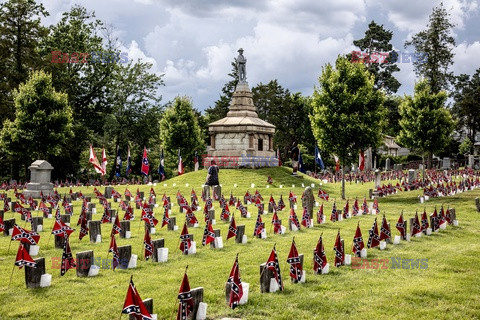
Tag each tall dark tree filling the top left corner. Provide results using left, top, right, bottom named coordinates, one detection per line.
left=0, top=0, right=49, bottom=128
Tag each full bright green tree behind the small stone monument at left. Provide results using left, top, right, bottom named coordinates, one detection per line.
left=0, top=71, right=73, bottom=178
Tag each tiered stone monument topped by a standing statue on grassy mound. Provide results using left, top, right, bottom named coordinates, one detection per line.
left=204, top=48, right=278, bottom=168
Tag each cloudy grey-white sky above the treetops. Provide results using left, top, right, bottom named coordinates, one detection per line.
left=37, top=0, right=480, bottom=110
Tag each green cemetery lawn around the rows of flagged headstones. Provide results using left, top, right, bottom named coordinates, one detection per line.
left=0, top=168, right=480, bottom=319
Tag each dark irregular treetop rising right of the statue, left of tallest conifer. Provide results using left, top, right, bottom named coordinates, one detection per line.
left=353, top=20, right=400, bottom=94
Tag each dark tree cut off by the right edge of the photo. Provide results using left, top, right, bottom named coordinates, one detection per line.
left=452, top=68, right=480, bottom=153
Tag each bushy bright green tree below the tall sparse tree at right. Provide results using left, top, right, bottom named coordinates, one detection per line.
left=398, top=80, right=454, bottom=167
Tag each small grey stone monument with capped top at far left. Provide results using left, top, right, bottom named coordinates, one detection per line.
left=23, top=160, right=53, bottom=198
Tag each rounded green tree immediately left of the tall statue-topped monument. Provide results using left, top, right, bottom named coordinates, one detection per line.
left=160, top=97, right=205, bottom=175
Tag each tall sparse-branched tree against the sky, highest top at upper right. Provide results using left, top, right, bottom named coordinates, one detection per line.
left=405, top=3, right=455, bottom=93
